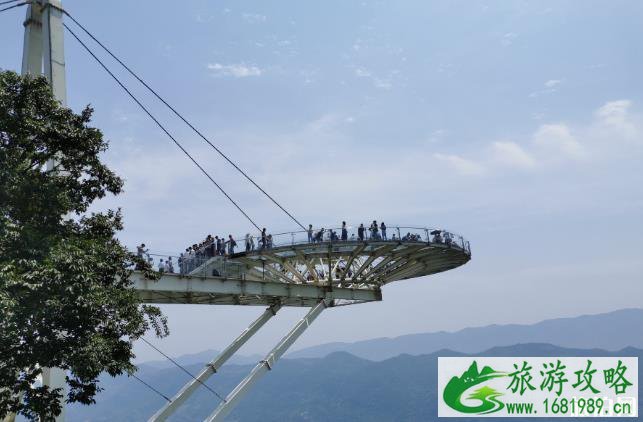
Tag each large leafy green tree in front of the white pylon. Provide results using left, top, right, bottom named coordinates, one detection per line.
left=0, top=72, right=168, bottom=420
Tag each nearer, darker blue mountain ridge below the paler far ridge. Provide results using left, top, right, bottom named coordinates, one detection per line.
left=67, top=343, right=643, bottom=422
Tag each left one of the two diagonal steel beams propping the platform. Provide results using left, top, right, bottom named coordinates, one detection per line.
left=149, top=305, right=281, bottom=422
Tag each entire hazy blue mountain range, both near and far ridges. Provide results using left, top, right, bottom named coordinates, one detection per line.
left=61, top=309, right=643, bottom=422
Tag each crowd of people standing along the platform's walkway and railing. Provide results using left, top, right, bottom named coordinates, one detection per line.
left=136, top=220, right=460, bottom=274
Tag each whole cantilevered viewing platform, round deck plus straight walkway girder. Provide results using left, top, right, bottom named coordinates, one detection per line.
left=134, top=226, right=471, bottom=306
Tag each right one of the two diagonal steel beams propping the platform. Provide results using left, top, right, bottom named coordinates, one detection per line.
left=206, top=300, right=330, bottom=422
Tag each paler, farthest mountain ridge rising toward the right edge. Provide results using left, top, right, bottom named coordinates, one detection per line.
left=286, top=309, right=643, bottom=361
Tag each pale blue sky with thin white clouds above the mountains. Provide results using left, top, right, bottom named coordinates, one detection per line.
left=0, top=0, right=643, bottom=361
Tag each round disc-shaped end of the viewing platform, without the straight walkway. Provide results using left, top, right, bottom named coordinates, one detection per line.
left=228, top=227, right=471, bottom=288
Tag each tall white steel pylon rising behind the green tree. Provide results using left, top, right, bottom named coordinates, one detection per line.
left=22, top=0, right=67, bottom=422
